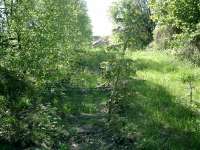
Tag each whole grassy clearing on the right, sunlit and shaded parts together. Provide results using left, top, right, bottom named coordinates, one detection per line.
left=127, top=51, right=200, bottom=149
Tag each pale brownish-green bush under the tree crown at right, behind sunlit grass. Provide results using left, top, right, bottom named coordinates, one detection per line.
left=149, top=23, right=200, bottom=65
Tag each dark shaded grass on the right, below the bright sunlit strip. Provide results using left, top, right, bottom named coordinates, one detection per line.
left=125, top=80, right=200, bottom=150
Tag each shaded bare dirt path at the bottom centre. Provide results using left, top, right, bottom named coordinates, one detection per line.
left=68, top=113, right=113, bottom=150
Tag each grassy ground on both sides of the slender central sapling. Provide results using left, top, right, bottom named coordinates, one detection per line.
left=59, top=49, right=200, bottom=150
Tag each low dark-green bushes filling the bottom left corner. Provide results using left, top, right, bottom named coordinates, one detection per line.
left=0, top=98, right=68, bottom=149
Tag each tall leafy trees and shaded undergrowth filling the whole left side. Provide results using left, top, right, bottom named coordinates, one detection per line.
left=0, top=0, right=92, bottom=149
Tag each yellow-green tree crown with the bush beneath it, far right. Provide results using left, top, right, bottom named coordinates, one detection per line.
left=150, top=0, right=200, bottom=64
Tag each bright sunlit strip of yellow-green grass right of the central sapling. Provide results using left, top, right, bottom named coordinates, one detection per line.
left=127, top=51, right=200, bottom=101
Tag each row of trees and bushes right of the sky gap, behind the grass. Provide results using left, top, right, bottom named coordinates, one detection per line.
left=111, top=0, right=200, bottom=64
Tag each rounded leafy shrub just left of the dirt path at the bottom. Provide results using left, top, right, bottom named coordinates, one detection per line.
left=20, top=104, right=68, bottom=149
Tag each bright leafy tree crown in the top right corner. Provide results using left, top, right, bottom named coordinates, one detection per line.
left=150, top=0, right=200, bottom=31
